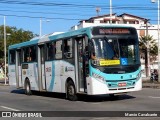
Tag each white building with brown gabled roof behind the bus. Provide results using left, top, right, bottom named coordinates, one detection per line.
left=71, top=13, right=158, bottom=77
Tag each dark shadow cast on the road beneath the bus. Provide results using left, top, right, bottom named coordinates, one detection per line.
left=11, top=89, right=135, bottom=102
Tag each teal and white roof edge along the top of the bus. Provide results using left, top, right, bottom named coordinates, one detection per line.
left=9, top=25, right=134, bottom=49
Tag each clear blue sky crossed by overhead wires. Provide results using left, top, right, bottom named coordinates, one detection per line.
left=0, top=0, right=158, bottom=35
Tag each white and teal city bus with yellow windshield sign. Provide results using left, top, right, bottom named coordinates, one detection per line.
left=8, top=25, right=142, bottom=101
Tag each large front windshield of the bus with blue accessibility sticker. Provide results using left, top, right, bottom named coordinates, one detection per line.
left=92, top=37, right=140, bottom=65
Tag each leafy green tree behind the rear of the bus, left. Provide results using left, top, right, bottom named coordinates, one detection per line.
left=0, top=25, right=37, bottom=62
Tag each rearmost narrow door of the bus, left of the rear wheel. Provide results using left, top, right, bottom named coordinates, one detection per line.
left=16, top=49, right=23, bottom=88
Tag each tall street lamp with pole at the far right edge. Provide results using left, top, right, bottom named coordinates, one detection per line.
left=151, top=0, right=160, bottom=81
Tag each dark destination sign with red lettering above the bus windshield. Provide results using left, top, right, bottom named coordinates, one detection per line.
left=92, top=27, right=132, bottom=35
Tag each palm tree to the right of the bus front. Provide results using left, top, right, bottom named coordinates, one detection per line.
left=139, top=35, right=158, bottom=77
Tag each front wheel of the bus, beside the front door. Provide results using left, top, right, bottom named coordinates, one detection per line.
left=66, top=80, right=77, bottom=101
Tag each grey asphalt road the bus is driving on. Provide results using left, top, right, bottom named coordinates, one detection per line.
left=0, top=86, right=160, bottom=120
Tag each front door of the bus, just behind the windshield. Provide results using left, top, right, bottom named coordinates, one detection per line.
left=75, top=37, right=88, bottom=92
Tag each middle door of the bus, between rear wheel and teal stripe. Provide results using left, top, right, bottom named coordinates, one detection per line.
left=38, top=45, right=46, bottom=90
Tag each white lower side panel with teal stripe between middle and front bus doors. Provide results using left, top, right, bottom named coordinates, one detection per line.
left=45, top=60, right=75, bottom=93
